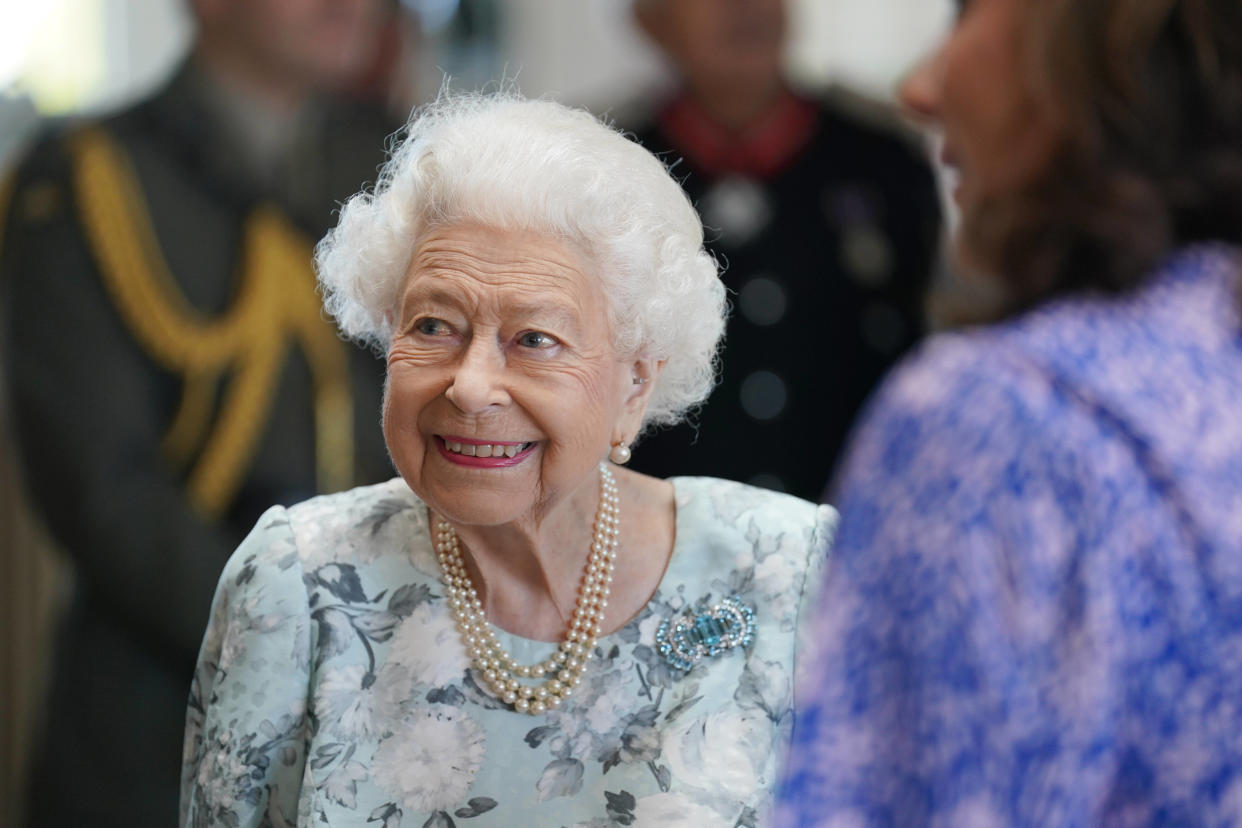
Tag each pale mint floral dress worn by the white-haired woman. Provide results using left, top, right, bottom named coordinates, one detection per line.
left=181, top=478, right=836, bottom=828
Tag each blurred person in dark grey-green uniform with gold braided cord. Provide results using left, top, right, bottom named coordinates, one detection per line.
left=0, top=0, right=395, bottom=826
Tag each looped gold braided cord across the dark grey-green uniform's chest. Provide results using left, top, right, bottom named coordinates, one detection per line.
left=72, top=129, right=353, bottom=516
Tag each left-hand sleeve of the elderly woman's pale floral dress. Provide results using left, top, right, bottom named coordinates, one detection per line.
left=181, top=506, right=312, bottom=828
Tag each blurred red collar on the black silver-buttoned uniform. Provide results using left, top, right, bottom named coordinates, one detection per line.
left=660, top=92, right=816, bottom=179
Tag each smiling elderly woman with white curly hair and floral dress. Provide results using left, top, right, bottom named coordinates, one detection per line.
left=183, top=96, right=833, bottom=828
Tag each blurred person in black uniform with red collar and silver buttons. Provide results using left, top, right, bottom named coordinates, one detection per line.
left=625, top=0, right=940, bottom=500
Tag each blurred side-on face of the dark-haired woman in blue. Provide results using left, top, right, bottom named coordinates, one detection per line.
left=900, top=0, right=1061, bottom=221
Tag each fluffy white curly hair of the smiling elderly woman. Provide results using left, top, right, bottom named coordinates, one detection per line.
left=315, top=91, right=725, bottom=428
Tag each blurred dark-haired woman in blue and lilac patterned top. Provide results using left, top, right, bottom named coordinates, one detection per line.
left=777, top=0, right=1242, bottom=826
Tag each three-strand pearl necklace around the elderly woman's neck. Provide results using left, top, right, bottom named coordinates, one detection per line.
left=436, top=464, right=621, bottom=715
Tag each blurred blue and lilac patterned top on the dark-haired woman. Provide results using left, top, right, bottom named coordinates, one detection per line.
left=776, top=247, right=1242, bottom=827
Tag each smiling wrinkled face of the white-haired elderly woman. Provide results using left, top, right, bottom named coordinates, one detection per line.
left=384, top=225, right=653, bottom=525
